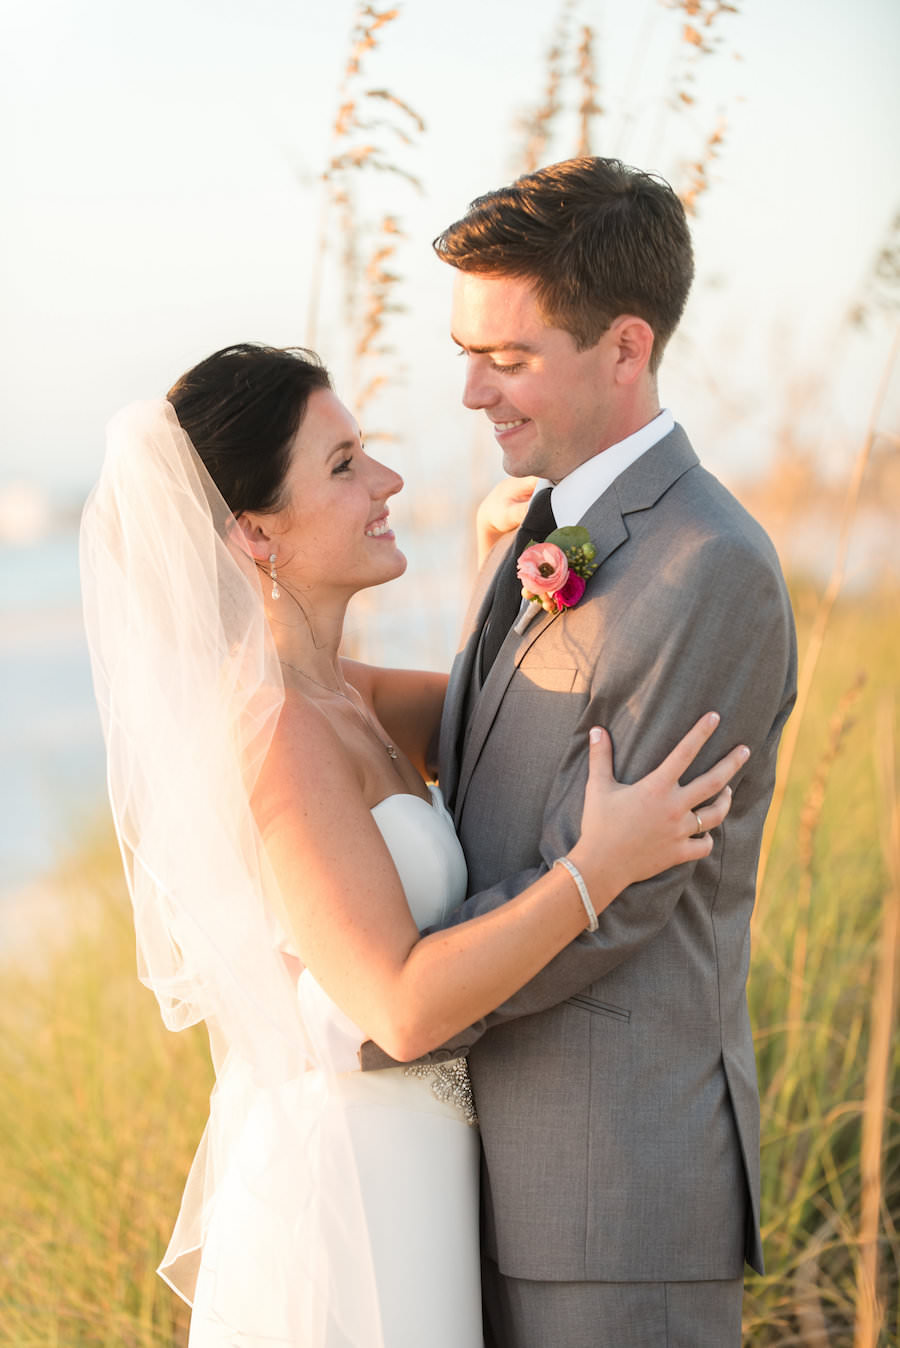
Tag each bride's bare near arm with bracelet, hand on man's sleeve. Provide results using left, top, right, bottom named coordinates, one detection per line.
left=253, top=697, right=742, bottom=1061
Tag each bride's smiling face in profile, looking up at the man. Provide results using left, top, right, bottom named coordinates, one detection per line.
left=261, top=388, right=407, bottom=592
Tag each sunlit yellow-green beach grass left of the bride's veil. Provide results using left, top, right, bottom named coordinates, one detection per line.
left=0, top=826, right=213, bottom=1348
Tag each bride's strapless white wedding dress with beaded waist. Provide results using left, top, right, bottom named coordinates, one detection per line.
left=181, top=787, right=482, bottom=1348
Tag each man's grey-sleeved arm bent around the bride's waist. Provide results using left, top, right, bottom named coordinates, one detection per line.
left=361, top=531, right=795, bottom=1068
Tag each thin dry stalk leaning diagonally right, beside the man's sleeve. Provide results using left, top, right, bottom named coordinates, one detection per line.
left=752, top=328, right=900, bottom=936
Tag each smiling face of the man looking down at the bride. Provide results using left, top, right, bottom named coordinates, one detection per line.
left=451, top=271, right=618, bottom=483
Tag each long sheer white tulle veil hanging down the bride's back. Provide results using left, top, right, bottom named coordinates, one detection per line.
left=81, top=399, right=380, bottom=1348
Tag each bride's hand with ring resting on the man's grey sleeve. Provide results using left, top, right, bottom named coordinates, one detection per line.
left=570, top=712, right=750, bottom=911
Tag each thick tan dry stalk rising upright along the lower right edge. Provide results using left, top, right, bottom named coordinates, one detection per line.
left=853, top=694, right=900, bottom=1348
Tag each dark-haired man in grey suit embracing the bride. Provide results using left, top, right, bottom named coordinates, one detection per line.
left=372, top=159, right=795, bottom=1348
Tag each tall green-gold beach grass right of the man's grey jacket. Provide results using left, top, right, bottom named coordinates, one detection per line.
left=745, top=586, right=900, bottom=1348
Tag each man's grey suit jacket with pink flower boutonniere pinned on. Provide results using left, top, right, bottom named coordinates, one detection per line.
left=364, top=427, right=796, bottom=1282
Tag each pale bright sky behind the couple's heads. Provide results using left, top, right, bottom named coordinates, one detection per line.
left=0, top=0, right=900, bottom=493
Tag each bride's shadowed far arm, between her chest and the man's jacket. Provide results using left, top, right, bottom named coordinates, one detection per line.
left=341, top=659, right=447, bottom=780
